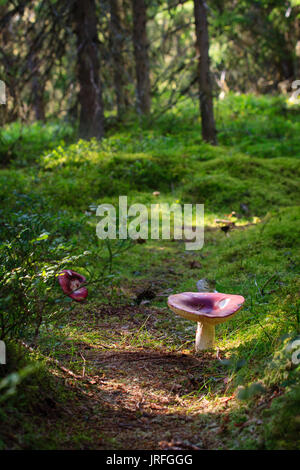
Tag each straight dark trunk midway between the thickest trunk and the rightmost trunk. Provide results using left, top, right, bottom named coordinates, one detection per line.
left=132, top=0, right=151, bottom=114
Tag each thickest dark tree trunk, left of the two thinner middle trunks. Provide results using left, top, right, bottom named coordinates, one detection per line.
left=73, top=0, right=104, bottom=139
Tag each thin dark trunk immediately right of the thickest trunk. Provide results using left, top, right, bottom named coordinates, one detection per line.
left=109, top=0, right=127, bottom=119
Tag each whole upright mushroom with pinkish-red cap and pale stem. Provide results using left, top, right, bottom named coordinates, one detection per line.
left=168, top=292, right=245, bottom=352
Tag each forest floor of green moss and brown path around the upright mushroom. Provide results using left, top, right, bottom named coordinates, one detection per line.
left=0, top=96, right=300, bottom=450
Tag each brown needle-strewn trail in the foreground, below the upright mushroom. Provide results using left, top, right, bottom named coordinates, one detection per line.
left=44, top=306, right=240, bottom=450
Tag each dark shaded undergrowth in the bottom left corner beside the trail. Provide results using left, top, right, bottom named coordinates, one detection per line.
left=0, top=342, right=97, bottom=450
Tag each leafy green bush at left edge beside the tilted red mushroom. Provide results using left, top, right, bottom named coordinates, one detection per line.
left=0, top=195, right=131, bottom=340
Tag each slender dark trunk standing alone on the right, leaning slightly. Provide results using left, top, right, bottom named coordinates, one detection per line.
left=194, top=0, right=217, bottom=145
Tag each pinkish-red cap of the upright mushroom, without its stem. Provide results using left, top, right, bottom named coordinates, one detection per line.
left=168, top=292, right=245, bottom=325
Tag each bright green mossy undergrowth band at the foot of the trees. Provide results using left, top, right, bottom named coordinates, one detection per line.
left=0, top=95, right=300, bottom=215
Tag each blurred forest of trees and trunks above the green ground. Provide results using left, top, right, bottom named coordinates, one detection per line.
left=0, top=0, right=300, bottom=138
